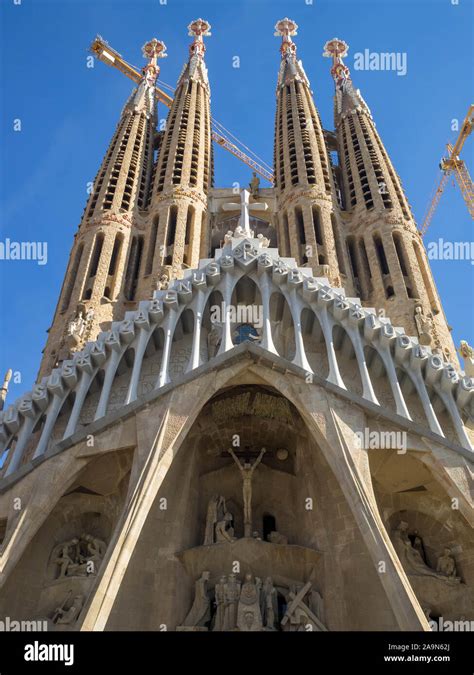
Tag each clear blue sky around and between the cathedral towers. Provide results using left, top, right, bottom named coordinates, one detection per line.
left=0, top=0, right=474, bottom=401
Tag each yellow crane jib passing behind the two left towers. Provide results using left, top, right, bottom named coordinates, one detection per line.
left=90, top=35, right=274, bottom=185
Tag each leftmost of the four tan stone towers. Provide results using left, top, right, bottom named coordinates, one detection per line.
left=39, top=38, right=166, bottom=378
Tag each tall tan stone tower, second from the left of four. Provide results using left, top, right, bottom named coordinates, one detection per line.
left=142, top=19, right=213, bottom=290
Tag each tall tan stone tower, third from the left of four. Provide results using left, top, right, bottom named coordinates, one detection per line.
left=274, top=19, right=346, bottom=285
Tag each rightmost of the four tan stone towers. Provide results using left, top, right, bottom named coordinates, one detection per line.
left=324, top=38, right=456, bottom=361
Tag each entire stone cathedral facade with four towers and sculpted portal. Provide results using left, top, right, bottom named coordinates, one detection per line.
left=0, top=19, right=474, bottom=631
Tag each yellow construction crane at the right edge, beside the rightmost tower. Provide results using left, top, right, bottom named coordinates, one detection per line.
left=420, top=105, right=474, bottom=236
